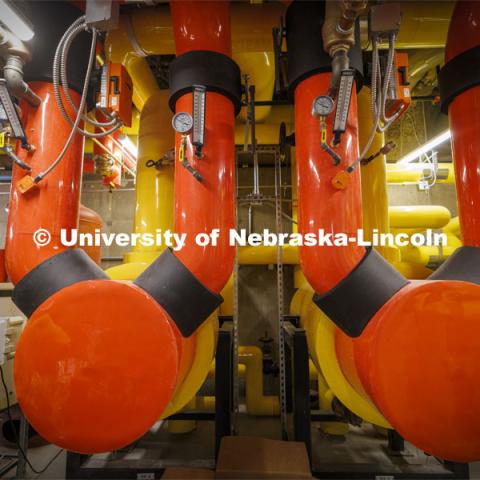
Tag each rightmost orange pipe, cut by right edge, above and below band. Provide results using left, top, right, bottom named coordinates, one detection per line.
left=445, top=1, right=480, bottom=247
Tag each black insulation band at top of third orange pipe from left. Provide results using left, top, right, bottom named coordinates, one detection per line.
left=286, top=0, right=363, bottom=93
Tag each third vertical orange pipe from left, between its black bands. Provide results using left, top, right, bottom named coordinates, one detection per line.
left=295, top=73, right=365, bottom=294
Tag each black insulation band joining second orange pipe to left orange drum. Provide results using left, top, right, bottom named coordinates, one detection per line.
left=134, top=249, right=223, bottom=337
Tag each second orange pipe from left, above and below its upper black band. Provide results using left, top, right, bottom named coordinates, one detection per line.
left=171, top=1, right=235, bottom=293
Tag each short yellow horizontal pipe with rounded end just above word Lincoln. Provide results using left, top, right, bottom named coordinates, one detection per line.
left=388, top=205, right=451, bottom=229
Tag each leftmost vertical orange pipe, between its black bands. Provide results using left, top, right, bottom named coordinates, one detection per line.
left=5, top=82, right=83, bottom=284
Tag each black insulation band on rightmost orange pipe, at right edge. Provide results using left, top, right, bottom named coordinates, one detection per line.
left=438, top=45, right=480, bottom=114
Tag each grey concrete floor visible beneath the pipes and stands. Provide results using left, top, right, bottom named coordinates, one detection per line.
left=0, top=415, right=480, bottom=480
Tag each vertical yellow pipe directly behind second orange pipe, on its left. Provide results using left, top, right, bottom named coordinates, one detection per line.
left=124, top=90, right=175, bottom=263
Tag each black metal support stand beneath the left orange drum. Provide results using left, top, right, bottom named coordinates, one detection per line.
left=65, top=317, right=233, bottom=480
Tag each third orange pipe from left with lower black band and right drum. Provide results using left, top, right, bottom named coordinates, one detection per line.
left=287, top=2, right=480, bottom=462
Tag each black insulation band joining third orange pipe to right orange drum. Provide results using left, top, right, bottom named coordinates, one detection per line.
left=313, top=247, right=409, bottom=337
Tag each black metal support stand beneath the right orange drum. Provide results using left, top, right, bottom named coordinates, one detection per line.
left=284, top=317, right=470, bottom=480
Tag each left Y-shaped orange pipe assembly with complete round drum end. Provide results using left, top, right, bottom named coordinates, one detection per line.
left=6, top=2, right=240, bottom=453
